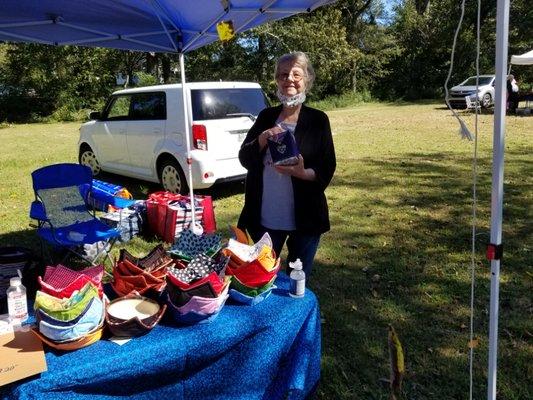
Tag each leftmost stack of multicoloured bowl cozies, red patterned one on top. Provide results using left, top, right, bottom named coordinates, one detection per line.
left=33, top=265, right=105, bottom=350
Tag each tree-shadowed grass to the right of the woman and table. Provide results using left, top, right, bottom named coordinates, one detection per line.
left=309, top=149, right=533, bottom=399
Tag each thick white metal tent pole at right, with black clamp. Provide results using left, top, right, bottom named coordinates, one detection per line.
left=487, top=0, right=509, bottom=400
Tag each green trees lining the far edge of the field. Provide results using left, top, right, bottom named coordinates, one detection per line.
left=0, top=0, right=533, bottom=121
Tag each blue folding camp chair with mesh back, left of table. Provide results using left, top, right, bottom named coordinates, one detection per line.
left=30, top=164, right=120, bottom=265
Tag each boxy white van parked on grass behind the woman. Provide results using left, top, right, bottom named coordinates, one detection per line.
left=78, top=82, right=268, bottom=193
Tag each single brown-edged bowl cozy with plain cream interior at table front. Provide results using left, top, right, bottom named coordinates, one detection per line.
left=106, top=293, right=167, bottom=337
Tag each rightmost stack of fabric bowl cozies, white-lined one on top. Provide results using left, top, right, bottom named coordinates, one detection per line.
left=222, top=233, right=280, bottom=305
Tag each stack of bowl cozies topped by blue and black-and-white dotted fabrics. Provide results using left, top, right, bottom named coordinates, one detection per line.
left=165, top=230, right=229, bottom=324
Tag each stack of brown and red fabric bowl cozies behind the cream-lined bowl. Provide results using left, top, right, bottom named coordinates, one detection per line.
left=111, top=245, right=172, bottom=299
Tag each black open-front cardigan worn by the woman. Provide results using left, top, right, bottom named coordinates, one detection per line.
left=238, top=106, right=336, bottom=234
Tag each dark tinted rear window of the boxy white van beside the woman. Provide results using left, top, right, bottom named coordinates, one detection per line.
left=191, top=88, right=268, bottom=121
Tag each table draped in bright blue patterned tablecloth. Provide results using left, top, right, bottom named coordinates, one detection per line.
left=0, top=273, right=321, bottom=400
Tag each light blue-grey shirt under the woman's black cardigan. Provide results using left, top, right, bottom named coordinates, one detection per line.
left=261, top=123, right=296, bottom=231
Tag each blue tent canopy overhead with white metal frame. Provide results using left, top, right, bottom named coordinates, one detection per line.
left=0, top=0, right=335, bottom=53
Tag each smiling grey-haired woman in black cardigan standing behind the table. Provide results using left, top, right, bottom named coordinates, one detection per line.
left=238, top=52, right=336, bottom=276
